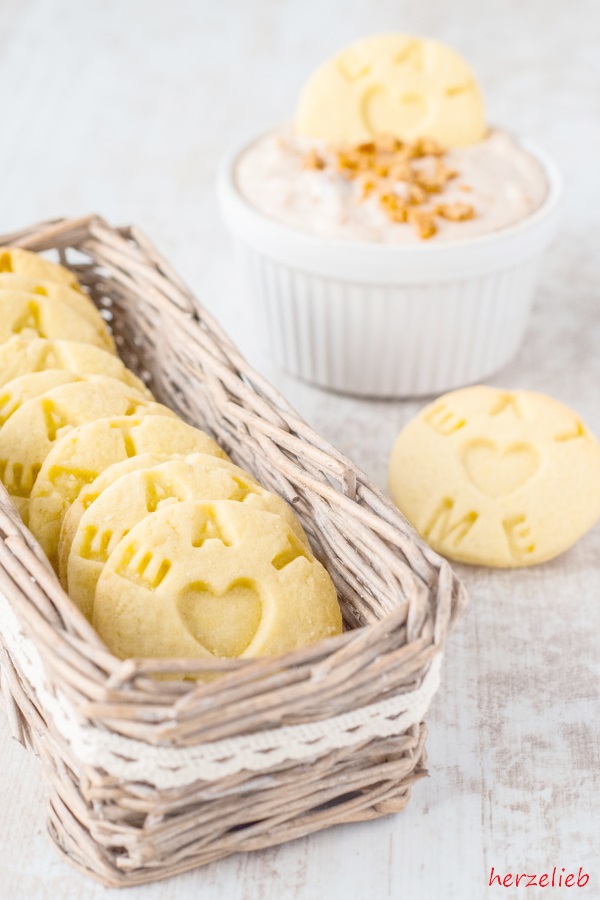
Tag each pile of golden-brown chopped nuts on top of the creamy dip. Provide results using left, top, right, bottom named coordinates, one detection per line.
left=302, top=134, right=475, bottom=240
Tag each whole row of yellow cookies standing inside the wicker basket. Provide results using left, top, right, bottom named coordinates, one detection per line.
left=0, top=248, right=342, bottom=659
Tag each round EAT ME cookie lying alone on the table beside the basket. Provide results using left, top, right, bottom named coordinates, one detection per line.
left=389, top=386, right=600, bottom=567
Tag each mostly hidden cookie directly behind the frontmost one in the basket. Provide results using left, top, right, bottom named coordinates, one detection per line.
left=59, top=453, right=312, bottom=619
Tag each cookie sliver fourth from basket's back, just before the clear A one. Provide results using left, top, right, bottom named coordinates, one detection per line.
left=0, top=335, right=151, bottom=397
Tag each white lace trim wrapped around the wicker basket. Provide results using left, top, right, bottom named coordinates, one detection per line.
left=0, top=593, right=441, bottom=789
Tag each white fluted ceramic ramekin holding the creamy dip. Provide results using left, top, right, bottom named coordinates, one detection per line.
left=218, top=134, right=562, bottom=397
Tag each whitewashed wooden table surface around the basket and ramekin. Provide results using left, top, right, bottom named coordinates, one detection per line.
left=0, top=0, right=600, bottom=900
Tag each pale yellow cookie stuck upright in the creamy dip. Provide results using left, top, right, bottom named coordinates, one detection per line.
left=295, top=34, right=486, bottom=147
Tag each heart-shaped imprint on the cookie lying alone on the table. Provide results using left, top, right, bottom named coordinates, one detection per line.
left=462, top=438, right=540, bottom=497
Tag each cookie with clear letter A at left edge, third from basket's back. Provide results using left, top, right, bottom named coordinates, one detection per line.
left=0, top=291, right=114, bottom=351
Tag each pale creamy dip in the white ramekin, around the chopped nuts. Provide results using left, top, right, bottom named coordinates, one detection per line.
left=236, top=129, right=548, bottom=244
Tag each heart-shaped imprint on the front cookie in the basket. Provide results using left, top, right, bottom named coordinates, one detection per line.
left=175, top=579, right=262, bottom=658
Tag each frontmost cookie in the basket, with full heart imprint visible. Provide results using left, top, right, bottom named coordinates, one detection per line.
left=92, top=500, right=342, bottom=659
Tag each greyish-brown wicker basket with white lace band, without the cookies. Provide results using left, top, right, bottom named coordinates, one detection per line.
left=0, top=216, right=466, bottom=886
